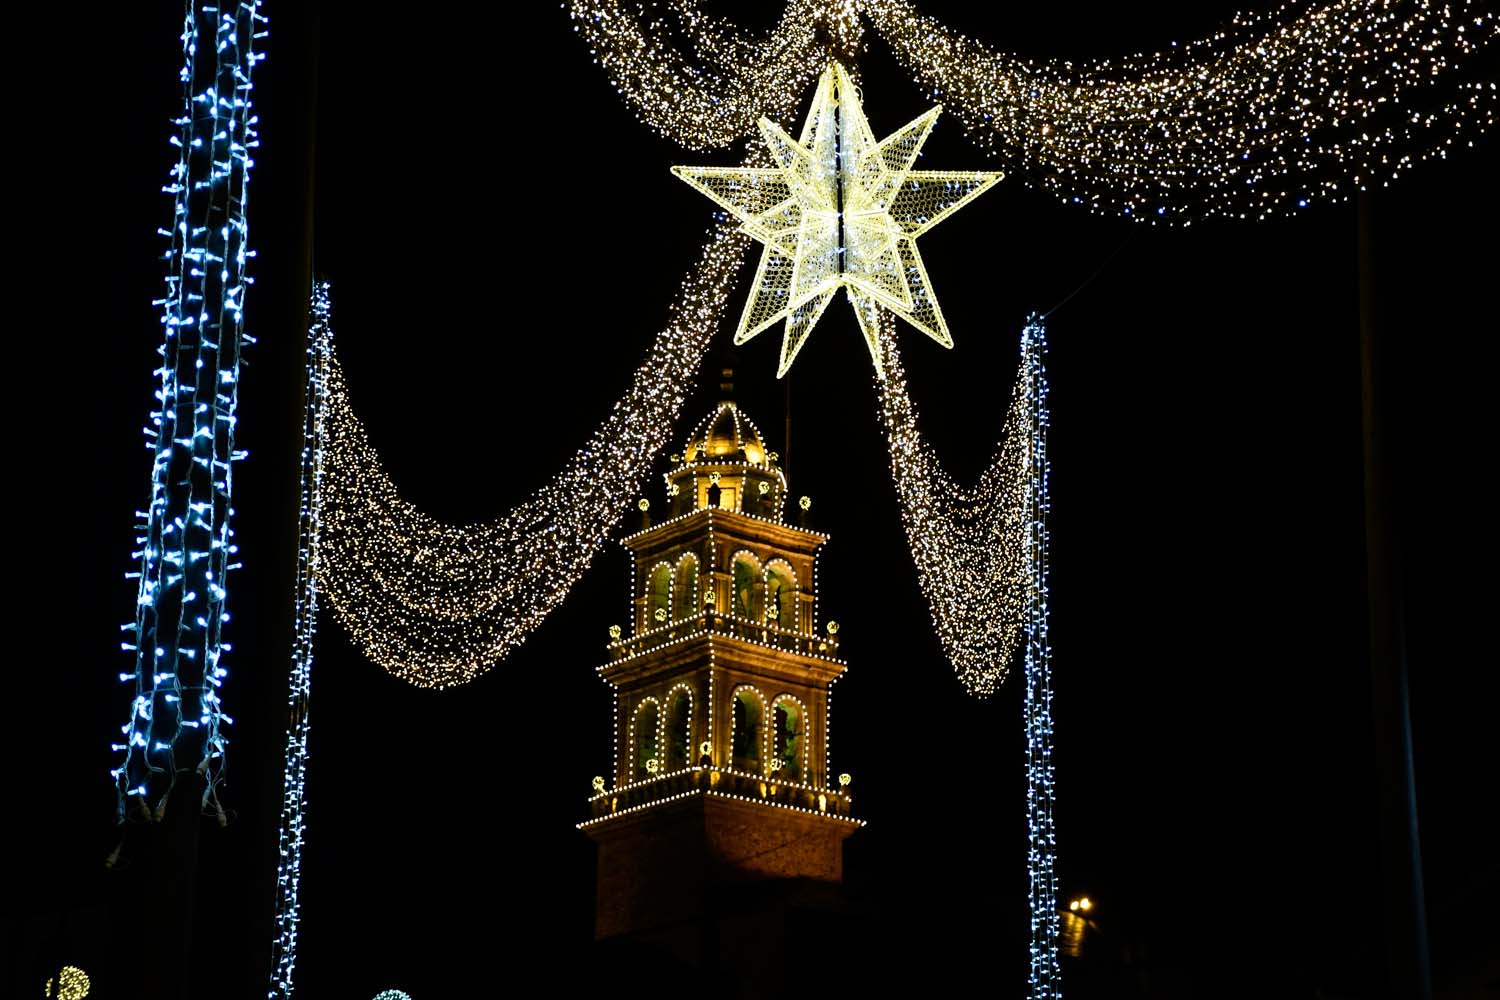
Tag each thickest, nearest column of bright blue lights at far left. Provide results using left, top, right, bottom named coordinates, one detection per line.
left=111, top=0, right=267, bottom=825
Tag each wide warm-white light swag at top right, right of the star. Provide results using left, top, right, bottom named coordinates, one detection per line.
left=860, top=0, right=1500, bottom=223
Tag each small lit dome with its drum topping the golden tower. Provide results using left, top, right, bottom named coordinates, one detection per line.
left=666, top=400, right=786, bottom=520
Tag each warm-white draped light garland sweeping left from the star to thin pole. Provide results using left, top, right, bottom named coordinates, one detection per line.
left=318, top=223, right=749, bottom=688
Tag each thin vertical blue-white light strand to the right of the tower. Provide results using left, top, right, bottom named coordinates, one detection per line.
left=1022, top=315, right=1062, bottom=1000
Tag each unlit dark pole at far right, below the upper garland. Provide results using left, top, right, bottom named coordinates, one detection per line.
left=1359, top=192, right=1433, bottom=1000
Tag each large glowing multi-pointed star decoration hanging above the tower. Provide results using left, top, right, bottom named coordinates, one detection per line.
left=672, top=63, right=1004, bottom=378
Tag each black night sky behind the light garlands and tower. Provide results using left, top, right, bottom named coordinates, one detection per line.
left=6, top=0, right=1500, bottom=1000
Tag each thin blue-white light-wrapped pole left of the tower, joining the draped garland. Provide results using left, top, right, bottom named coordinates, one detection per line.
left=267, top=282, right=333, bottom=1000
